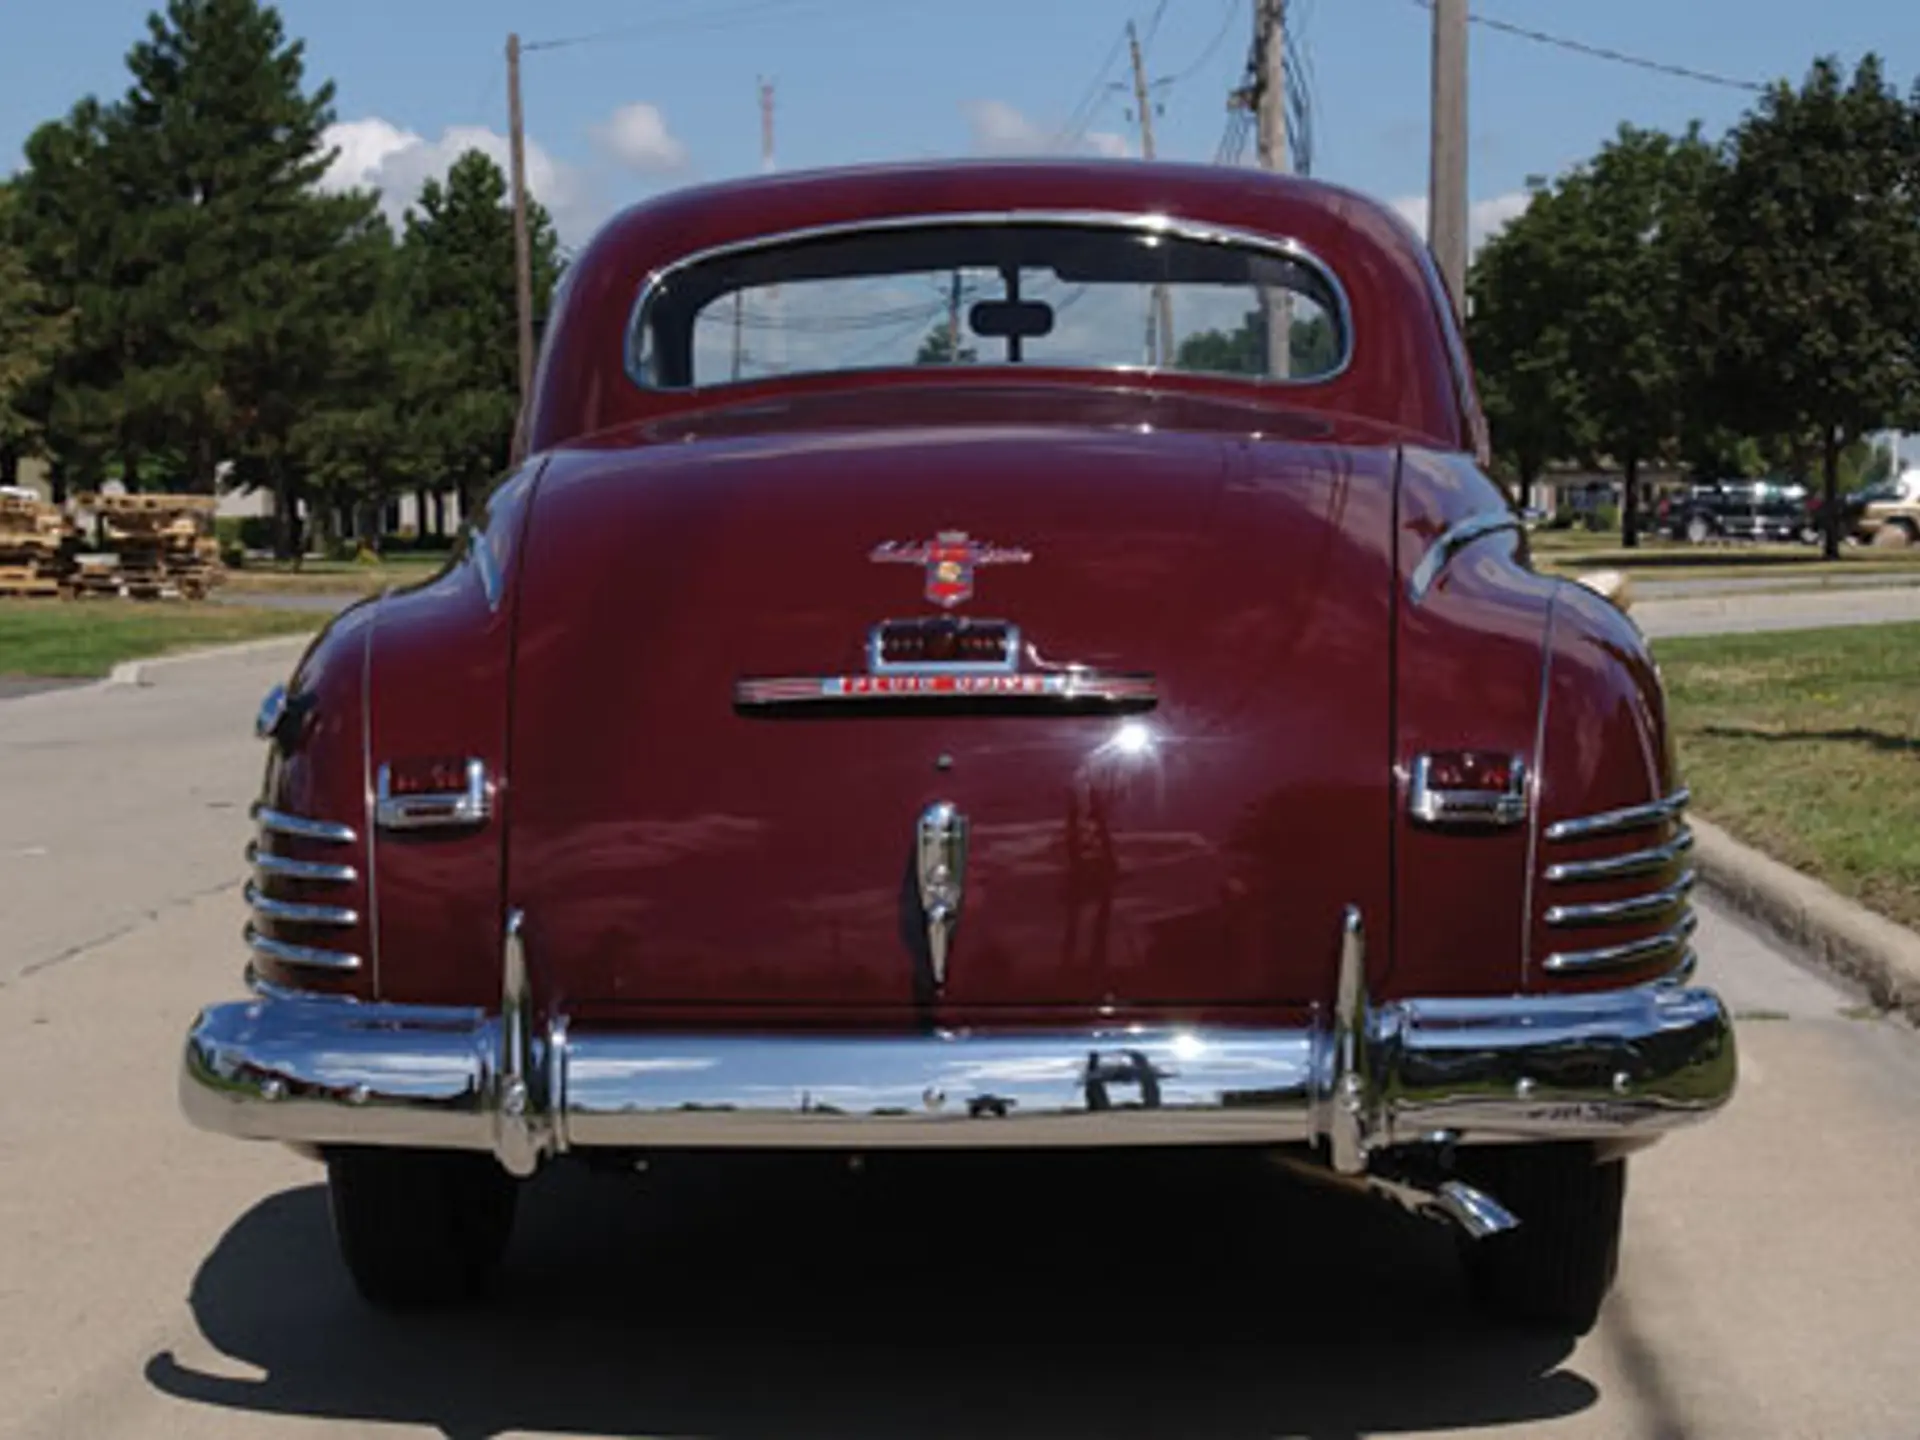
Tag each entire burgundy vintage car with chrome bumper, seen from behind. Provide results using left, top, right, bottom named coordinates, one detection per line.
left=182, top=161, right=1736, bottom=1329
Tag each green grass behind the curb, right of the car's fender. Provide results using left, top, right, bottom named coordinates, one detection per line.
left=1653, top=624, right=1920, bottom=927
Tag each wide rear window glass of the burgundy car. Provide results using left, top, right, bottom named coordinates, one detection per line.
left=632, top=221, right=1352, bottom=390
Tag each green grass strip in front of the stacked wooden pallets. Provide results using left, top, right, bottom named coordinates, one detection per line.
left=0, top=599, right=324, bottom=676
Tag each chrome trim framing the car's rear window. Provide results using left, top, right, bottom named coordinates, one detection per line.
left=622, top=209, right=1356, bottom=396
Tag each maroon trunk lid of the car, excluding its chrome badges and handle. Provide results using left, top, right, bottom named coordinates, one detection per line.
left=509, top=391, right=1394, bottom=1023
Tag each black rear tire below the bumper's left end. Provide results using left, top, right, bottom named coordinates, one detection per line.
left=326, top=1150, right=518, bottom=1309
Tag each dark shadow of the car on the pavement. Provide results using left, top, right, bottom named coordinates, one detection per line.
left=146, top=1154, right=1597, bottom=1440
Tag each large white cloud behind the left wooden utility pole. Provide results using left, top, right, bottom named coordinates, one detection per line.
left=321, top=115, right=605, bottom=246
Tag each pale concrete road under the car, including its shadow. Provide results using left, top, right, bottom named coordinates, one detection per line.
left=0, top=647, right=1920, bottom=1440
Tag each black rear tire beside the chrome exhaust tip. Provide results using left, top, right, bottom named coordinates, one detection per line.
left=1461, top=1146, right=1626, bottom=1334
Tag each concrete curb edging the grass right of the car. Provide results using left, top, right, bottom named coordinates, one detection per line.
left=1688, top=816, right=1920, bottom=1021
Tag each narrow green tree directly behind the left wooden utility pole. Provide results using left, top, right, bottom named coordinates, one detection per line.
left=401, top=150, right=559, bottom=513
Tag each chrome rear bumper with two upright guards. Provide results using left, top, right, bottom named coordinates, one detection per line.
left=180, top=912, right=1736, bottom=1175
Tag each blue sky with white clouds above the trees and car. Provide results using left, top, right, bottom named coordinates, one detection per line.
left=0, top=0, right=1920, bottom=253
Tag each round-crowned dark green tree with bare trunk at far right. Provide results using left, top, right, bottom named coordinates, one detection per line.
left=1693, top=56, right=1920, bottom=559
